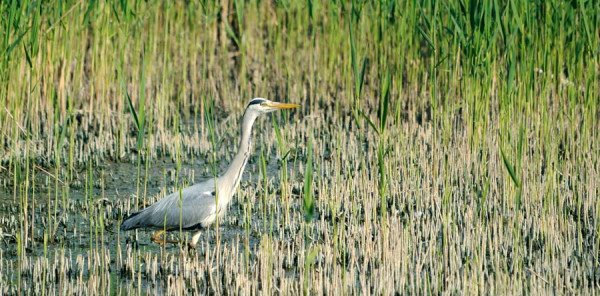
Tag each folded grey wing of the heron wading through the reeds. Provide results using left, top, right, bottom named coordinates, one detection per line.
left=121, top=180, right=216, bottom=230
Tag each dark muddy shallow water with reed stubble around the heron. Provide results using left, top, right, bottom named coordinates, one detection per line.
left=0, top=153, right=300, bottom=292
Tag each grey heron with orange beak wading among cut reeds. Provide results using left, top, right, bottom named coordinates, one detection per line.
left=121, top=98, right=300, bottom=248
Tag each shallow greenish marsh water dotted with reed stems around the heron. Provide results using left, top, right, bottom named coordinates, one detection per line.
left=0, top=154, right=296, bottom=294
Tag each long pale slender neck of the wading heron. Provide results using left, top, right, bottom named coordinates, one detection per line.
left=219, top=112, right=257, bottom=198
